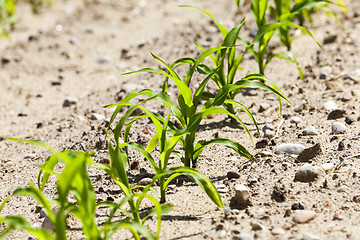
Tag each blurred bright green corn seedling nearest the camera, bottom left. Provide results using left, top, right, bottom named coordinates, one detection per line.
left=0, top=138, right=165, bottom=240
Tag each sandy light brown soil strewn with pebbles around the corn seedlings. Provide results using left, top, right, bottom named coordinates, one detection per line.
left=0, top=0, right=360, bottom=240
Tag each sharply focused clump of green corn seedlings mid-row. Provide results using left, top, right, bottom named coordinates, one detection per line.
left=105, top=46, right=285, bottom=202
